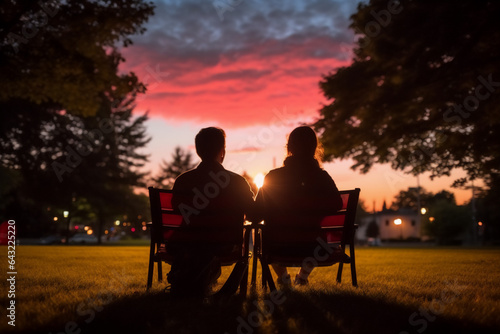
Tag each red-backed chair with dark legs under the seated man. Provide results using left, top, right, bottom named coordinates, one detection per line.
left=147, top=187, right=251, bottom=294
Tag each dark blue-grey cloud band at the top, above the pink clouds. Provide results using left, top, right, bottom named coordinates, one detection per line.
left=134, top=0, right=357, bottom=66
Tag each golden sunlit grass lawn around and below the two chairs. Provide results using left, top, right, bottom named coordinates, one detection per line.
left=0, top=246, right=500, bottom=334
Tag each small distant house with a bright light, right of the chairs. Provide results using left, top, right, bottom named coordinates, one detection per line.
left=356, top=202, right=423, bottom=242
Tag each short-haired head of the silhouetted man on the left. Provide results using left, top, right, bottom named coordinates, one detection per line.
left=194, top=127, right=226, bottom=163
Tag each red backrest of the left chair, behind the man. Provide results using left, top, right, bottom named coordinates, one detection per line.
left=148, top=187, right=243, bottom=243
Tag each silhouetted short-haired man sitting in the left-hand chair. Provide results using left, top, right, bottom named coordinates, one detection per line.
left=167, top=127, right=253, bottom=296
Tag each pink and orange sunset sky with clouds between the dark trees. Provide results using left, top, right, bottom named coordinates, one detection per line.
left=118, top=0, right=471, bottom=210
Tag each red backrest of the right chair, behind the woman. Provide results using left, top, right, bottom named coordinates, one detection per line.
left=264, top=188, right=360, bottom=244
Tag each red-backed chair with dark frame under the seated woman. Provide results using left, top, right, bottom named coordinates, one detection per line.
left=252, top=188, right=360, bottom=290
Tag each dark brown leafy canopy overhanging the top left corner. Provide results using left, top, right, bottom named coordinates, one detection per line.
left=0, top=0, right=153, bottom=119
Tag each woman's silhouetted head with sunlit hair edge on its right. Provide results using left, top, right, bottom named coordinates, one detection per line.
left=287, top=126, right=323, bottom=161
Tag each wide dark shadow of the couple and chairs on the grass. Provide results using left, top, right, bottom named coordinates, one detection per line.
left=17, top=289, right=498, bottom=334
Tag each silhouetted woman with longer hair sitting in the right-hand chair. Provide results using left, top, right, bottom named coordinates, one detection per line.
left=254, top=126, right=342, bottom=285
